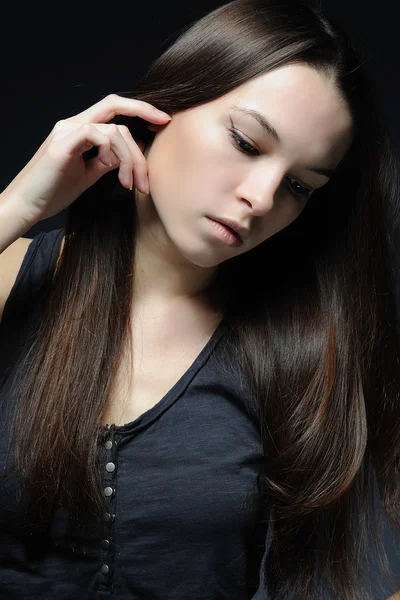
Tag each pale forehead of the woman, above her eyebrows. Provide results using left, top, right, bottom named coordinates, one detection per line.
left=210, top=64, right=352, bottom=162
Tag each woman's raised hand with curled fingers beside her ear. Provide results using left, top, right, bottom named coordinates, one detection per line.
left=2, top=94, right=170, bottom=229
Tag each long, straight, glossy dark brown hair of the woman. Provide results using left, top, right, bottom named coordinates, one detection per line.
left=3, top=0, right=400, bottom=600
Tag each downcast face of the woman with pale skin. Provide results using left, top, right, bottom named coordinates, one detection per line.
left=137, top=65, right=352, bottom=267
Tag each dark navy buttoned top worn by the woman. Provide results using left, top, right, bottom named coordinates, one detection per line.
left=0, top=229, right=268, bottom=600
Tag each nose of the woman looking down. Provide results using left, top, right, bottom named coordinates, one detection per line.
left=236, top=168, right=282, bottom=217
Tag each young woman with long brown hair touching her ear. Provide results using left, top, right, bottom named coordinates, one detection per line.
left=0, top=0, right=400, bottom=600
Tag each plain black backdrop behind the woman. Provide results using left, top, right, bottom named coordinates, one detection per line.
left=0, top=0, right=400, bottom=592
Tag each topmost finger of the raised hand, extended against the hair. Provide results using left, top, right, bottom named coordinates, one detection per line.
left=66, top=94, right=170, bottom=123
